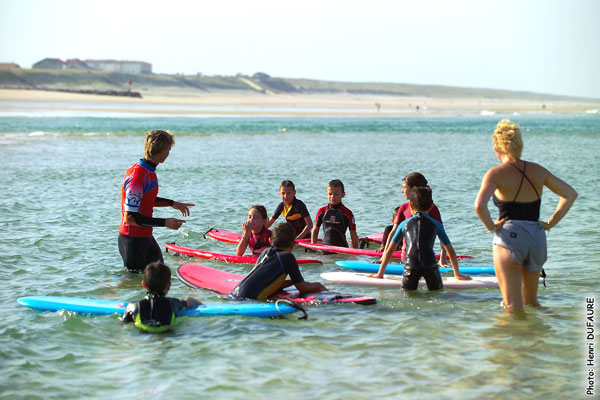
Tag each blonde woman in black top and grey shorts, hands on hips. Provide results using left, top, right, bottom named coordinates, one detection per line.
left=475, top=120, right=577, bottom=312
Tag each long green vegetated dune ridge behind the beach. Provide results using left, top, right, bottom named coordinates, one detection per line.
left=0, top=68, right=591, bottom=101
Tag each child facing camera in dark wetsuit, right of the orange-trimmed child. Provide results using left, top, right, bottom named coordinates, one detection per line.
left=311, top=179, right=358, bottom=249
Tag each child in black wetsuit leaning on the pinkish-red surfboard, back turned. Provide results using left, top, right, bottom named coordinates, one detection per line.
left=230, top=222, right=327, bottom=300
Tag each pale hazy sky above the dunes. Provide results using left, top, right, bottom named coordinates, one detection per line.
left=0, top=0, right=600, bottom=99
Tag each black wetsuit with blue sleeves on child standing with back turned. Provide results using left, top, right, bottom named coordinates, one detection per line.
left=392, top=212, right=450, bottom=290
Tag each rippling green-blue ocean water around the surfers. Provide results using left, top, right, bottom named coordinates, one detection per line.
left=0, top=111, right=600, bottom=399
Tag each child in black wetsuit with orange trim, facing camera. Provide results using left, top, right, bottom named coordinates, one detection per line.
left=266, top=180, right=313, bottom=239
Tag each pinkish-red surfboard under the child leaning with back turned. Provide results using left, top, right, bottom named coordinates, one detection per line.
left=177, top=264, right=377, bottom=305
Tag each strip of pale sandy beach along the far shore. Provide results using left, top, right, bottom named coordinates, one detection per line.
left=0, top=89, right=600, bottom=116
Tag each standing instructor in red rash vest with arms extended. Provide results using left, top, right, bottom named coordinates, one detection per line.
left=119, top=130, right=194, bottom=272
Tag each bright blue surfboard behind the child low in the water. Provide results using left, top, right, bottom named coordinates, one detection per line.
left=17, top=296, right=298, bottom=317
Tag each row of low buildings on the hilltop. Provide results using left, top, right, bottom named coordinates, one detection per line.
left=32, top=58, right=152, bottom=74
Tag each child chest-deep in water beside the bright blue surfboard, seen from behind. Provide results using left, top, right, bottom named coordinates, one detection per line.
left=123, top=261, right=202, bottom=332
